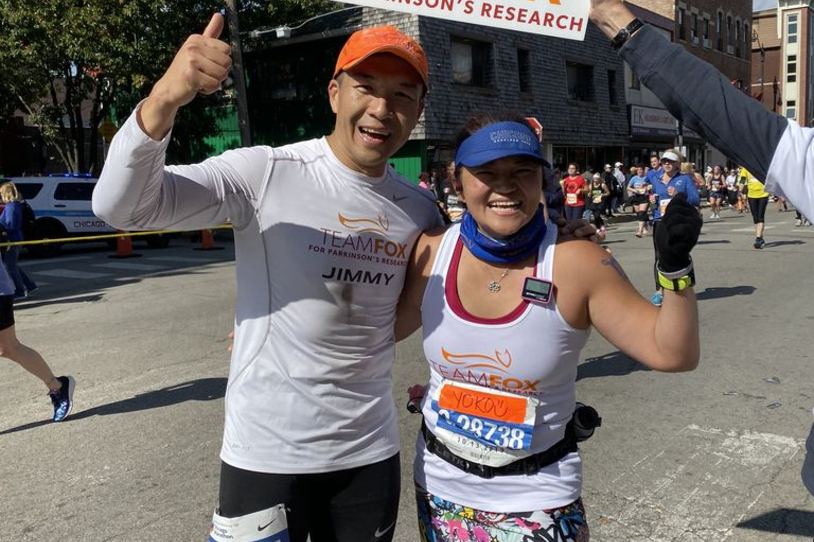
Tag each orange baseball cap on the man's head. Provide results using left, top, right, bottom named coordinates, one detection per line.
left=334, top=26, right=429, bottom=88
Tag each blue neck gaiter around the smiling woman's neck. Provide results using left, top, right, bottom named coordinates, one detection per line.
left=461, top=205, right=546, bottom=263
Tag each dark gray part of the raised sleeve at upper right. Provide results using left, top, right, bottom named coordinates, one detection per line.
left=620, top=25, right=789, bottom=183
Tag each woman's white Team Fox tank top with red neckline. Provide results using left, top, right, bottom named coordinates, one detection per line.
left=414, top=224, right=590, bottom=512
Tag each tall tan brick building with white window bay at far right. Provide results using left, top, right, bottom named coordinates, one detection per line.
left=752, top=0, right=814, bottom=126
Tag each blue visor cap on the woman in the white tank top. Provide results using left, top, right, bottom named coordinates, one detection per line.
left=455, top=122, right=549, bottom=167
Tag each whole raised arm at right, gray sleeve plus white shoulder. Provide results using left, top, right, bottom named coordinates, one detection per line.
left=620, top=26, right=814, bottom=218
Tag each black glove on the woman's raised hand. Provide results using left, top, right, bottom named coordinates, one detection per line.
left=655, top=194, right=703, bottom=273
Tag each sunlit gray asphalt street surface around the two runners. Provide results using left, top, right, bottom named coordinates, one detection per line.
left=0, top=208, right=814, bottom=542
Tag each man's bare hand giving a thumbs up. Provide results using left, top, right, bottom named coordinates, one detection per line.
left=138, top=13, right=232, bottom=140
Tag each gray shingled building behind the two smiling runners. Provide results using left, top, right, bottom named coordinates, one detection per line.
left=245, top=7, right=628, bottom=180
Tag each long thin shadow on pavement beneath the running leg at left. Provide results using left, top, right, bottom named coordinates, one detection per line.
left=0, top=378, right=226, bottom=436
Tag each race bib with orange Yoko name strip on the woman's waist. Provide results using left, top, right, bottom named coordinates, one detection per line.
left=431, top=381, right=539, bottom=467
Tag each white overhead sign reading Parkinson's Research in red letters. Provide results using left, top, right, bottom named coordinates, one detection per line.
left=338, top=0, right=590, bottom=41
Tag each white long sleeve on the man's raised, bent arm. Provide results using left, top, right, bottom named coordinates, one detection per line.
left=93, top=105, right=270, bottom=230
